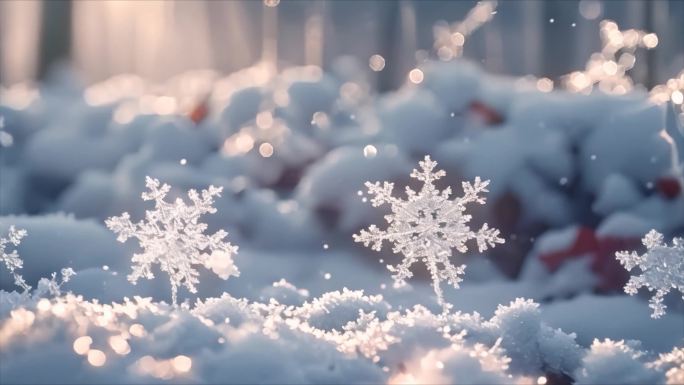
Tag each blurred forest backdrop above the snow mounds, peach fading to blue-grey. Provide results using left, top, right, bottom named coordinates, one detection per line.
left=0, top=0, right=684, bottom=90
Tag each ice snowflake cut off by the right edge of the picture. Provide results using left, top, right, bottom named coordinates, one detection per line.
left=615, top=230, right=684, bottom=318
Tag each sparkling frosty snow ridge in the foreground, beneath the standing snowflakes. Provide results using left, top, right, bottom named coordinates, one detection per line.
left=0, top=289, right=684, bottom=384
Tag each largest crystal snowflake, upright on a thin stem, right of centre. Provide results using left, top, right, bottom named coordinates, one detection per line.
left=354, top=156, right=504, bottom=311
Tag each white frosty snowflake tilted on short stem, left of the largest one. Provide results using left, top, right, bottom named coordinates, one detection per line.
left=106, top=176, right=240, bottom=305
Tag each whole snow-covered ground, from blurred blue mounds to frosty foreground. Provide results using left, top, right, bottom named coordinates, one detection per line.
left=0, top=60, right=684, bottom=384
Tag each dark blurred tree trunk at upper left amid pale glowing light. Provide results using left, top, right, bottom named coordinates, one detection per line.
left=38, top=0, right=71, bottom=79
